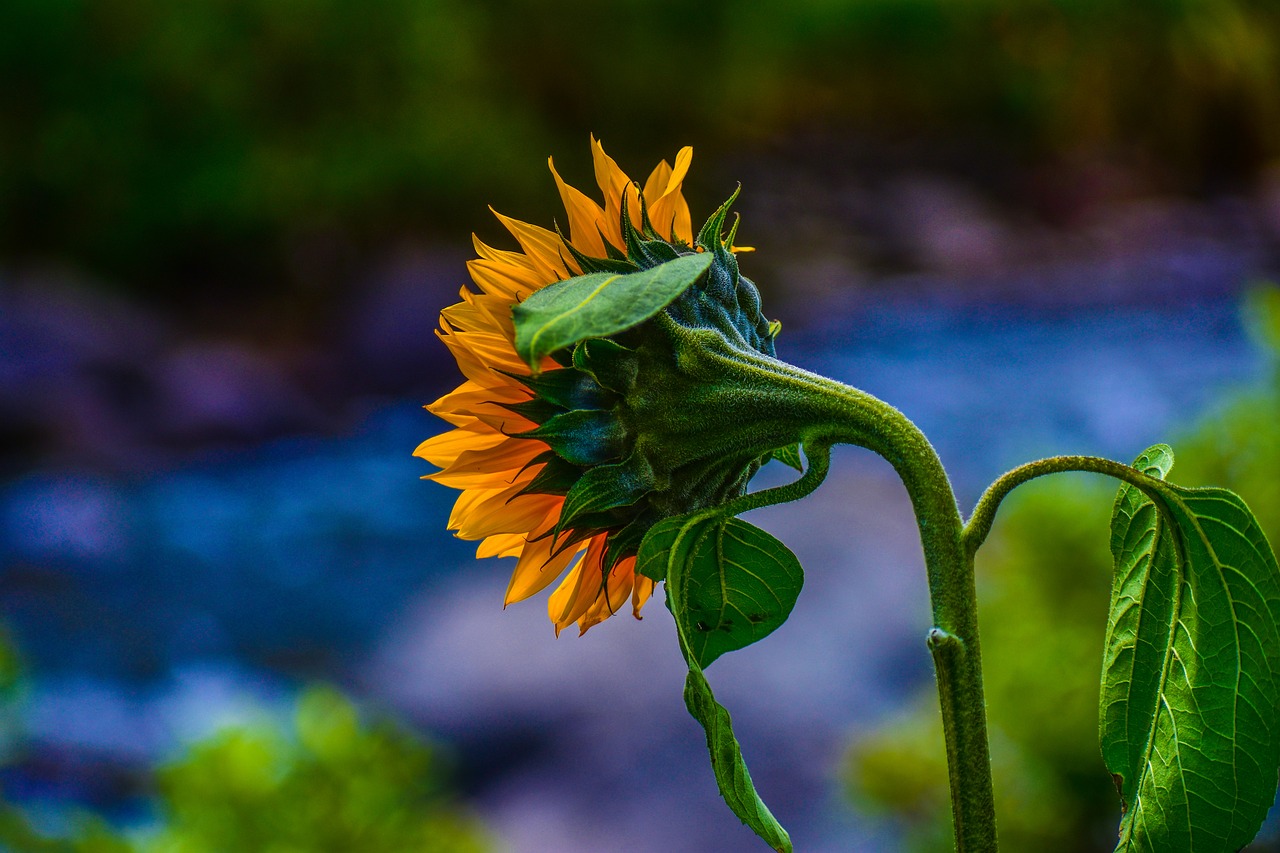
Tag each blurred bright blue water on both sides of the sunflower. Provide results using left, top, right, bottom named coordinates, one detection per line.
left=0, top=289, right=1265, bottom=845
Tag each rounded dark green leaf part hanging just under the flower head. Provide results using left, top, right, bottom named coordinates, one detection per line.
left=636, top=514, right=804, bottom=669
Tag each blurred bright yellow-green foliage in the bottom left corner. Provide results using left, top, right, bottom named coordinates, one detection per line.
left=0, top=688, right=492, bottom=853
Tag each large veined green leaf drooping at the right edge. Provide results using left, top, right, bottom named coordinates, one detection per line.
left=1100, top=444, right=1280, bottom=853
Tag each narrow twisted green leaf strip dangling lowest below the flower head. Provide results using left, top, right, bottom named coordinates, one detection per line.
left=636, top=510, right=799, bottom=853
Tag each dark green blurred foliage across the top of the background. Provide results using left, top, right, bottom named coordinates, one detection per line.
left=10, top=0, right=1280, bottom=287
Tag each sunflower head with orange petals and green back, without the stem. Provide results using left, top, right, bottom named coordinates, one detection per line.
left=417, top=140, right=787, bottom=633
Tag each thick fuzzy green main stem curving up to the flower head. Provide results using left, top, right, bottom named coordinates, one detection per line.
left=685, top=333, right=996, bottom=853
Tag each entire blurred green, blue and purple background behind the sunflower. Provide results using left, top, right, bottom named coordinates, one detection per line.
left=0, top=0, right=1280, bottom=853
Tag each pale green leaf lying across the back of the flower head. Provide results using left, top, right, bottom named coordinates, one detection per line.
left=512, top=252, right=713, bottom=373
